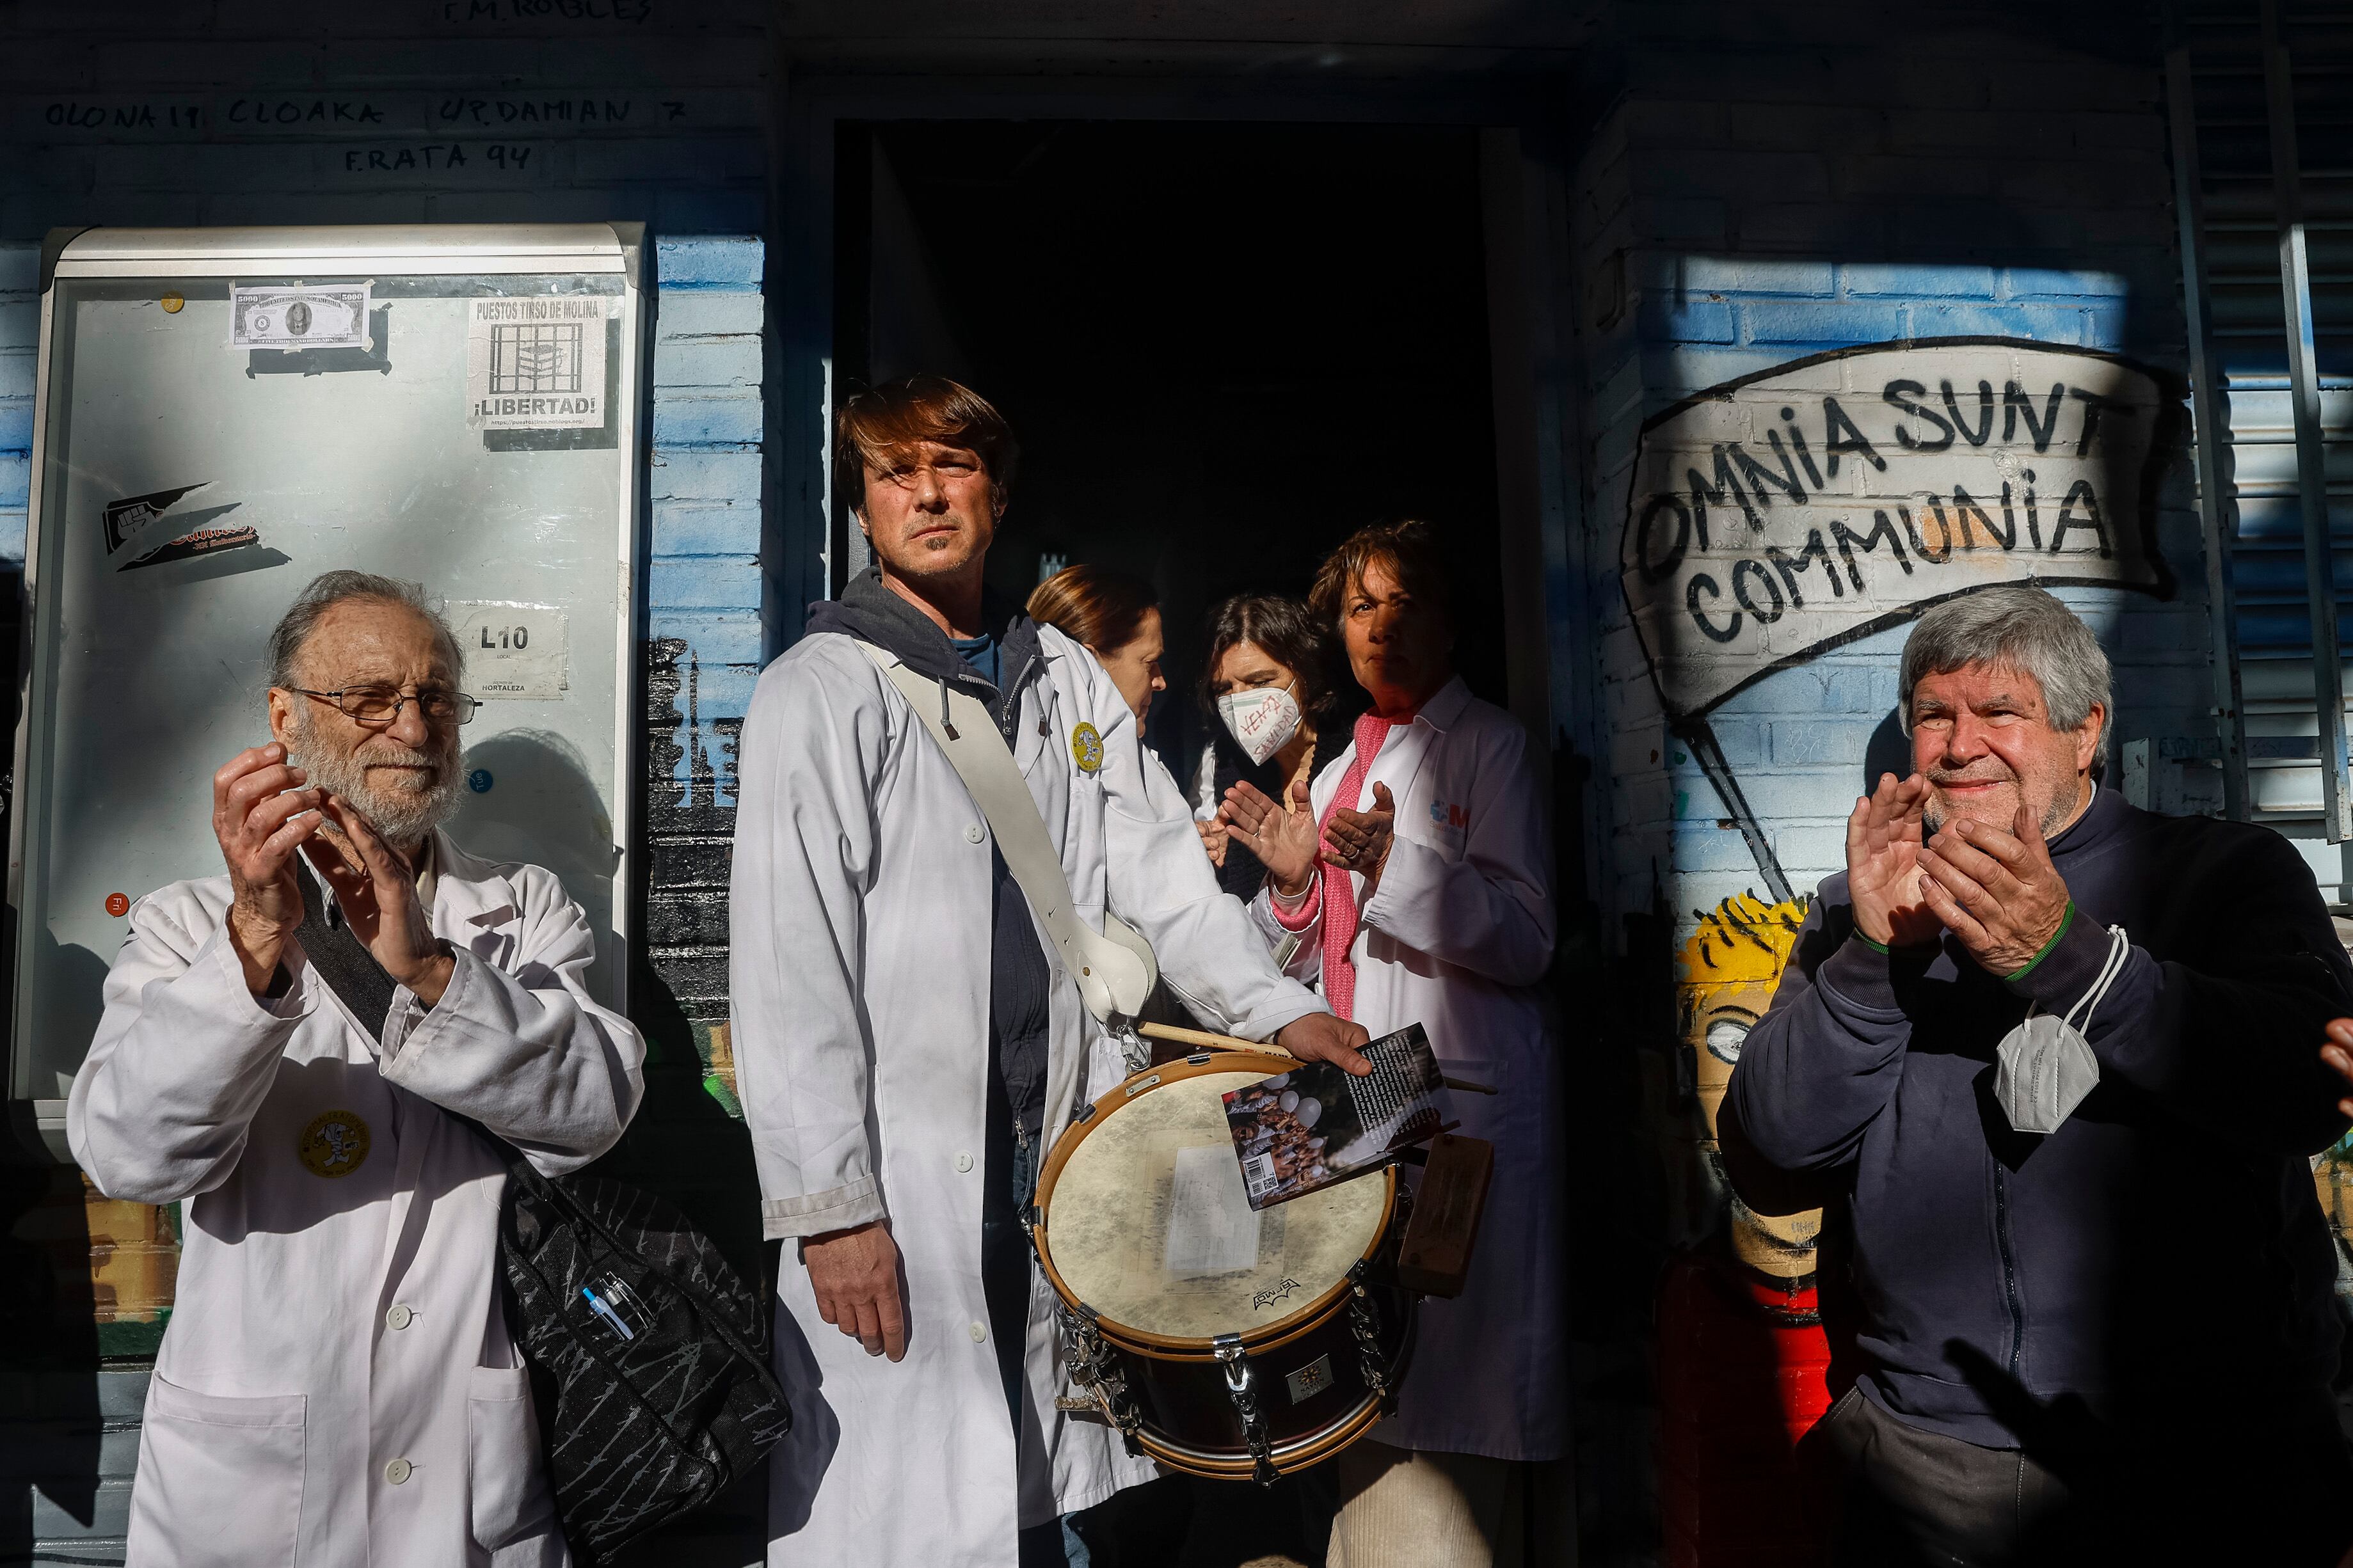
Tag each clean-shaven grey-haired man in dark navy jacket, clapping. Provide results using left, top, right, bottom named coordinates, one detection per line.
left=1720, top=588, right=2353, bottom=1568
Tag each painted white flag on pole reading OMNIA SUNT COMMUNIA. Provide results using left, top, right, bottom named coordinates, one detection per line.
left=1619, top=338, right=2183, bottom=898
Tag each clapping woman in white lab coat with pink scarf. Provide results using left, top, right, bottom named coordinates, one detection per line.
left=1224, top=524, right=1570, bottom=1568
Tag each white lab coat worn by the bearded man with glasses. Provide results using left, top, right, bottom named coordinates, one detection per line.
left=66, top=837, right=644, bottom=1568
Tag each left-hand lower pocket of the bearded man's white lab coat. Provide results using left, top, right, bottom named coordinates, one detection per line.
left=127, top=1377, right=308, bottom=1568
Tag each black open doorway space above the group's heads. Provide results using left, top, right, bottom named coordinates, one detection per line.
left=835, top=120, right=1504, bottom=776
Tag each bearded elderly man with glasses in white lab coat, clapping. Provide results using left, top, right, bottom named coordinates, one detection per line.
left=66, top=571, right=644, bottom=1568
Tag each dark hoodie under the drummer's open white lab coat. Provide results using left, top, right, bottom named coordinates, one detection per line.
left=807, top=571, right=1054, bottom=1143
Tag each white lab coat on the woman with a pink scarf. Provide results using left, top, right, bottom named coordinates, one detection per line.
left=1252, top=679, right=1570, bottom=1460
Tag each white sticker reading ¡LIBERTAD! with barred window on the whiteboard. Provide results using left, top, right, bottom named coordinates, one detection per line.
left=466, top=294, right=614, bottom=430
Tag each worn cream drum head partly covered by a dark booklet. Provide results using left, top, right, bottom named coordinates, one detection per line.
left=1045, top=1070, right=1393, bottom=1340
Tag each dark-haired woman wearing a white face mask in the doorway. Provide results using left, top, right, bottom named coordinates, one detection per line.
left=1188, top=595, right=1334, bottom=898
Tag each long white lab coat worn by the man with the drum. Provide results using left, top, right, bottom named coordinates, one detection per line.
left=730, top=628, right=1322, bottom=1568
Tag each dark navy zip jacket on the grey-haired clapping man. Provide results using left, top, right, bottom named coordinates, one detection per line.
left=1723, top=790, right=2353, bottom=1448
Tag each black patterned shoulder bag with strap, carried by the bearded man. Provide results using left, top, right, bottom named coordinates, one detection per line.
left=296, top=867, right=793, bottom=1568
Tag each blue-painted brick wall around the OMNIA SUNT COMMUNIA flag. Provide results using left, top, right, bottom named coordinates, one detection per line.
left=1570, top=43, right=2212, bottom=926
